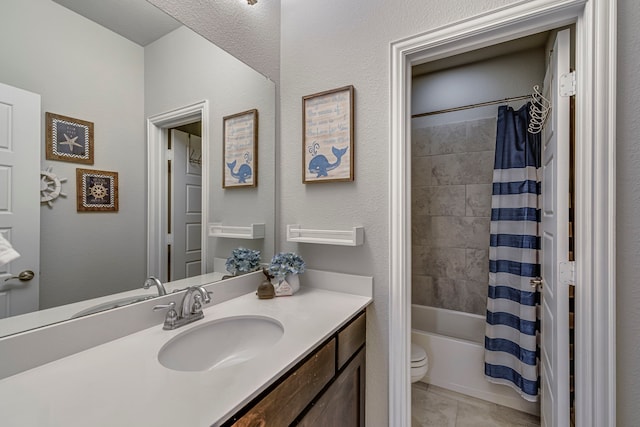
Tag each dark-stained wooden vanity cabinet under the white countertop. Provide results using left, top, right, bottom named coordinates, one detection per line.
left=223, top=312, right=366, bottom=427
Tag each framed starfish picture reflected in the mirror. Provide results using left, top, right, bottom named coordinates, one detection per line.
left=45, top=112, right=93, bottom=165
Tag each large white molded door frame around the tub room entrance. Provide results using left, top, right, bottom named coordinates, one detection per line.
left=389, top=0, right=616, bottom=427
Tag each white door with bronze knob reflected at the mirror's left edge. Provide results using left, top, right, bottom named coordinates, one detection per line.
left=0, top=83, right=40, bottom=319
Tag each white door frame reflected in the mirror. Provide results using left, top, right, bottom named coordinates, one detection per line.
left=147, top=100, right=210, bottom=282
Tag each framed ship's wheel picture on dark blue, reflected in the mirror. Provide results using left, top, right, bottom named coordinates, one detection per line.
left=76, top=168, right=118, bottom=212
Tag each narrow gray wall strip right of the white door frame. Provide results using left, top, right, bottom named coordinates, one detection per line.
left=616, top=0, right=640, bottom=427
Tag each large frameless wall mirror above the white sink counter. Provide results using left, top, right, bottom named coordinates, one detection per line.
left=0, top=0, right=275, bottom=337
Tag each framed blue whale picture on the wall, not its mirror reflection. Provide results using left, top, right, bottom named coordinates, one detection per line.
left=302, top=86, right=354, bottom=184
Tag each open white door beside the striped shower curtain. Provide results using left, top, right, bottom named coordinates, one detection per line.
left=540, top=30, right=570, bottom=427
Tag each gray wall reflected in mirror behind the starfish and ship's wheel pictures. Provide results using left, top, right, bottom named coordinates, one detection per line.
left=0, top=0, right=146, bottom=308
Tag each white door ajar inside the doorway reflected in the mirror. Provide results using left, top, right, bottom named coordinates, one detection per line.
left=171, top=129, right=202, bottom=280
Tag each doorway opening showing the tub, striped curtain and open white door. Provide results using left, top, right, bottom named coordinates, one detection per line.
left=411, top=29, right=575, bottom=425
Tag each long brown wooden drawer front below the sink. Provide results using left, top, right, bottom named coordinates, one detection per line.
left=233, top=338, right=336, bottom=426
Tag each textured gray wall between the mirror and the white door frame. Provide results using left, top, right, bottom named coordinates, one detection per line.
left=278, top=0, right=524, bottom=426
